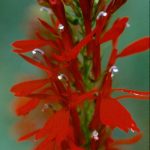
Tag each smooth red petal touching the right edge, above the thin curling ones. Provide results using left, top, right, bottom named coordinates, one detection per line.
left=118, top=37, right=150, bottom=57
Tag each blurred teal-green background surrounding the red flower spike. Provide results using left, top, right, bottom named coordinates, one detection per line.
left=0, top=0, right=149, bottom=150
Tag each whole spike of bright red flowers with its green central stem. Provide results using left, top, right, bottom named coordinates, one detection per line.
left=11, top=0, right=149, bottom=150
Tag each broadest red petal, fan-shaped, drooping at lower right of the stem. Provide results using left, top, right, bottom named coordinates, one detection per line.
left=100, top=98, right=139, bottom=132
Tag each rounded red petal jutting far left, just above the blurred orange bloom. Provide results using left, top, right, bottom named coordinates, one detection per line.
left=11, top=79, right=49, bottom=96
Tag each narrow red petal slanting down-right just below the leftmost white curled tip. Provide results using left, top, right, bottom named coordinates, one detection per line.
left=19, top=54, right=51, bottom=74
